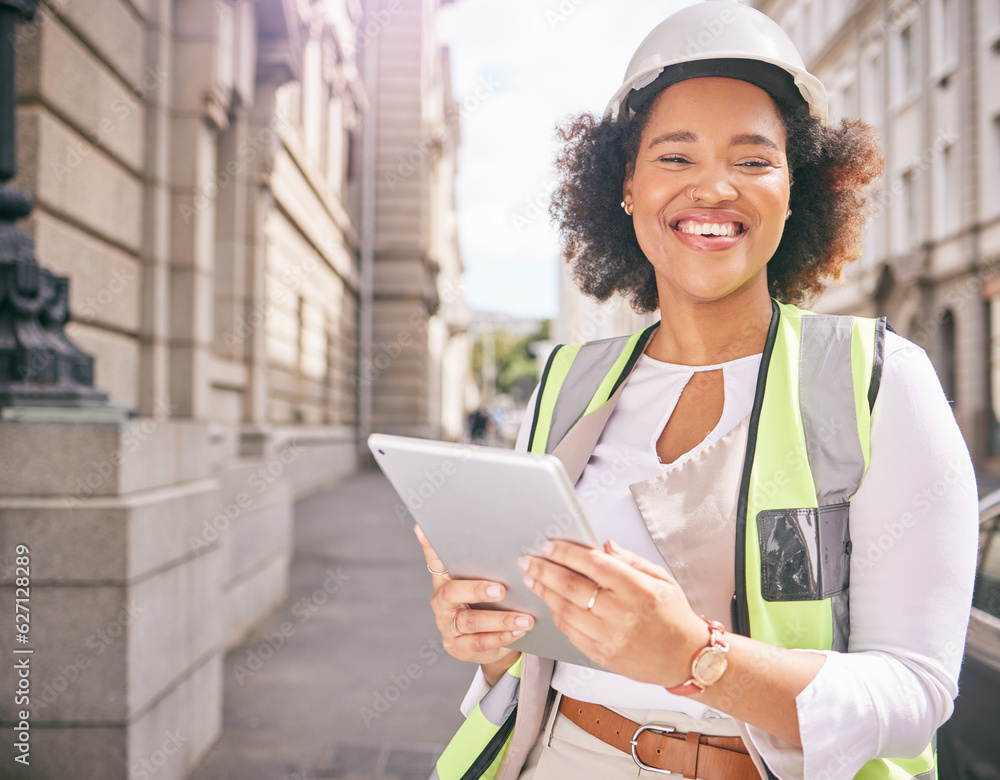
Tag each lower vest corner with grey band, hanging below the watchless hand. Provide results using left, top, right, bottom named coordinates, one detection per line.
left=428, top=657, right=522, bottom=780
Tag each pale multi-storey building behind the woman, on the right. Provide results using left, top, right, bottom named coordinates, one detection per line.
left=753, top=0, right=1000, bottom=485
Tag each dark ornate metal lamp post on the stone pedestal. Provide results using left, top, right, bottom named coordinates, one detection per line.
left=0, top=0, right=108, bottom=407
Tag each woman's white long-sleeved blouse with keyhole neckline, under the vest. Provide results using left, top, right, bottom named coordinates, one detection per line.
left=462, top=333, right=978, bottom=780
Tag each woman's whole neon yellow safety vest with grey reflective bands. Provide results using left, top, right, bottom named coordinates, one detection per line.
left=432, top=301, right=937, bottom=780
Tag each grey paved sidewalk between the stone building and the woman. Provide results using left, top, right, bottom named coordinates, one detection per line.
left=193, top=471, right=473, bottom=780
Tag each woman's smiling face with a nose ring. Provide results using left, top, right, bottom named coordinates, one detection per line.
left=624, top=77, right=789, bottom=309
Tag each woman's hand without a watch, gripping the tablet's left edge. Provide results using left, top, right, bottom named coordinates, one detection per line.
left=413, top=525, right=535, bottom=685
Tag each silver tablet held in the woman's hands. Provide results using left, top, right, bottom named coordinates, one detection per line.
left=368, top=433, right=601, bottom=669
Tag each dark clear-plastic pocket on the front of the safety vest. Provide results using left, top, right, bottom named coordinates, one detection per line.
left=757, top=501, right=851, bottom=601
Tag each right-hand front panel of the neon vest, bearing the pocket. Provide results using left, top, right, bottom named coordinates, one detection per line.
left=737, top=304, right=880, bottom=652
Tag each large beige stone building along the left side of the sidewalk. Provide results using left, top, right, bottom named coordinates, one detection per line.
left=0, top=0, right=468, bottom=780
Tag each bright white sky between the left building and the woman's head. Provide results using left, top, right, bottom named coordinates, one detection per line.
left=438, top=0, right=690, bottom=317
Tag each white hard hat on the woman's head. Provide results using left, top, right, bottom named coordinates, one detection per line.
left=604, top=0, right=827, bottom=125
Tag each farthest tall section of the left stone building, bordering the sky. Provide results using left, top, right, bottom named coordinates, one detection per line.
left=359, top=0, right=470, bottom=441
